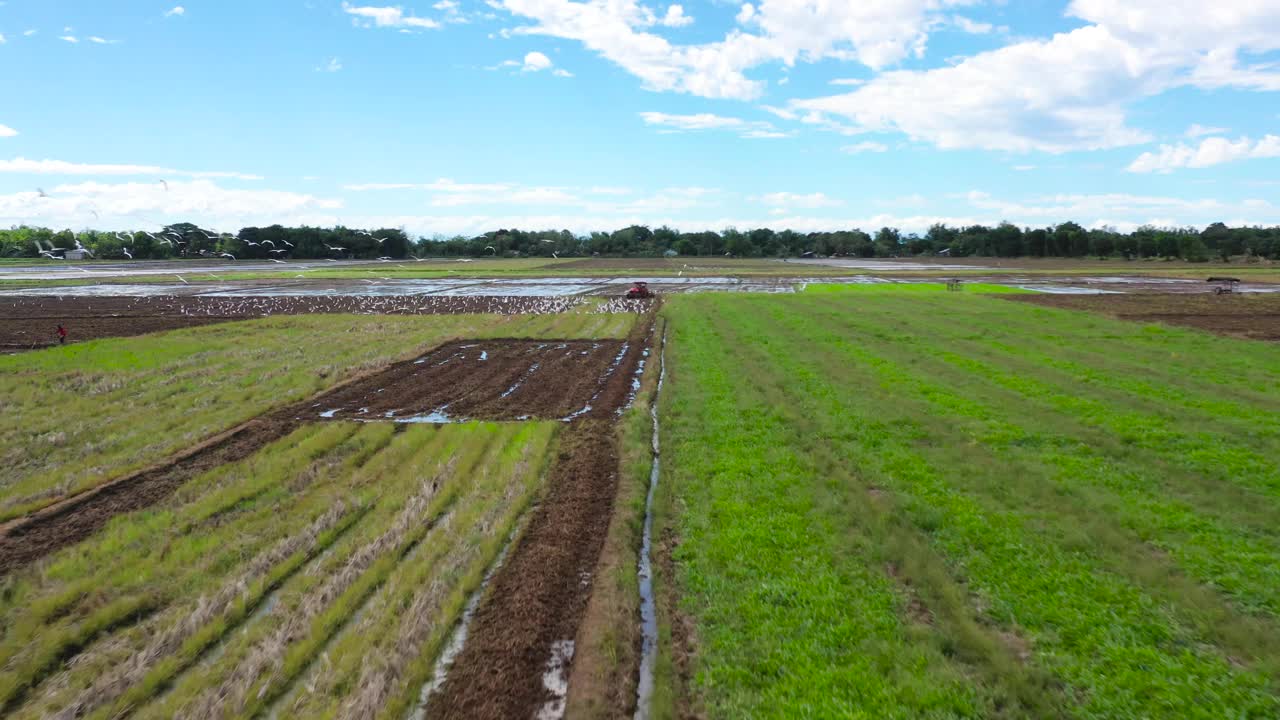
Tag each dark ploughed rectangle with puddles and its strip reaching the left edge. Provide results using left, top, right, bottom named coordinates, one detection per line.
left=0, top=333, right=641, bottom=573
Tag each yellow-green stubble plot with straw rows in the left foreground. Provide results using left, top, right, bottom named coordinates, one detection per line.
left=0, top=423, right=554, bottom=717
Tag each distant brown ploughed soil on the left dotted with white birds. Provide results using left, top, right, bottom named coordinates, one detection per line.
left=0, top=296, right=581, bottom=352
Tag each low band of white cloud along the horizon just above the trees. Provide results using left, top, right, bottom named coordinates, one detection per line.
left=0, top=181, right=1280, bottom=234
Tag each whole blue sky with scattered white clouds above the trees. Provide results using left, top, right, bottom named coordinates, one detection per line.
left=0, top=0, right=1280, bottom=234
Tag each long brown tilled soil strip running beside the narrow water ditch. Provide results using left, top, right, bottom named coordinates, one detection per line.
left=430, top=315, right=654, bottom=720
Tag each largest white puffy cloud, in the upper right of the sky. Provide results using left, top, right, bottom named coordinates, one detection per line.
left=795, top=0, right=1280, bottom=152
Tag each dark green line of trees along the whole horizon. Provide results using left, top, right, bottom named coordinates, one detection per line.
left=0, top=223, right=1280, bottom=263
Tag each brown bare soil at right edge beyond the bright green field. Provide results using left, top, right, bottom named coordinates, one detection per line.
left=997, top=292, right=1280, bottom=341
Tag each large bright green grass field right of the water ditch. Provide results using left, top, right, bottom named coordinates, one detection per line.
left=663, top=292, right=1280, bottom=719
